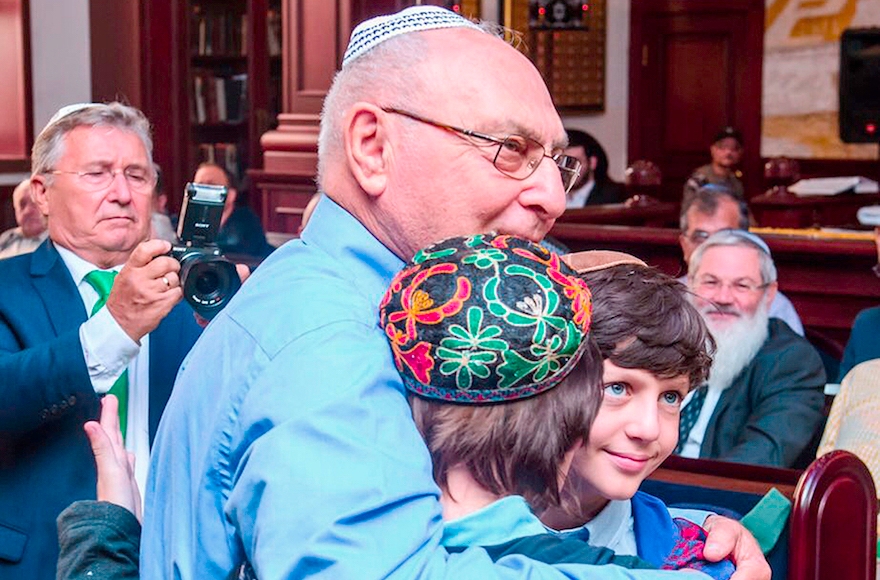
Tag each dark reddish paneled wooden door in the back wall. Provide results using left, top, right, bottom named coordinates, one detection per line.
left=628, top=0, right=764, bottom=201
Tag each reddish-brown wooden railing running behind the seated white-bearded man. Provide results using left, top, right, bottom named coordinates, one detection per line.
left=550, top=223, right=880, bottom=356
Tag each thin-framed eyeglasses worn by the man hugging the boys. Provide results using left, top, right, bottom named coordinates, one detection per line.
left=382, top=107, right=581, bottom=193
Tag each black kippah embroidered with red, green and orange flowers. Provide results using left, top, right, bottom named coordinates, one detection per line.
left=380, top=234, right=592, bottom=404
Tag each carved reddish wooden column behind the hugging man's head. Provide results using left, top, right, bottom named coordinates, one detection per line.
left=248, top=0, right=414, bottom=234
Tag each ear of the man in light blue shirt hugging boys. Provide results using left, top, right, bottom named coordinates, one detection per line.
left=343, top=103, right=389, bottom=201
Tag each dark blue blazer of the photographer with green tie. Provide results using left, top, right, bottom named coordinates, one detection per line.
left=0, top=242, right=201, bottom=580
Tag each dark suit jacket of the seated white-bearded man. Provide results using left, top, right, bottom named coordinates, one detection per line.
left=700, top=318, right=825, bottom=467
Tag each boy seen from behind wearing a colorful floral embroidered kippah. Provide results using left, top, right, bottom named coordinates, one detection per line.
left=380, top=235, right=733, bottom=578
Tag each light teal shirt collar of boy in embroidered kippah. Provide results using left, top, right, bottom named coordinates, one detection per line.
left=440, top=495, right=547, bottom=546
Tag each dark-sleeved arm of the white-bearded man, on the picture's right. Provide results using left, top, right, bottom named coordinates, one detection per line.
left=718, top=340, right=825, bottom=467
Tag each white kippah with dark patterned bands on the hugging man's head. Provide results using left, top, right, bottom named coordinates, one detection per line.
left=342, top=6, right=480, bottom=68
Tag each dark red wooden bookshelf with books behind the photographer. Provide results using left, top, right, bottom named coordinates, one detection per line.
left=132, top=0, right=283, bottom=211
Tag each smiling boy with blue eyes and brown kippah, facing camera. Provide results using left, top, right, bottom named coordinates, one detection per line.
left=541, top=251, right=728, bottom=565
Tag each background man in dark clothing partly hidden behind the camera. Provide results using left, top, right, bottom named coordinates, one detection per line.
left=193, top=163, right=275, bottom=260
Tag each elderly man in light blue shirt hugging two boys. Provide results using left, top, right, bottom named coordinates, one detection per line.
left=141, top=6, right=769, bottom=580
